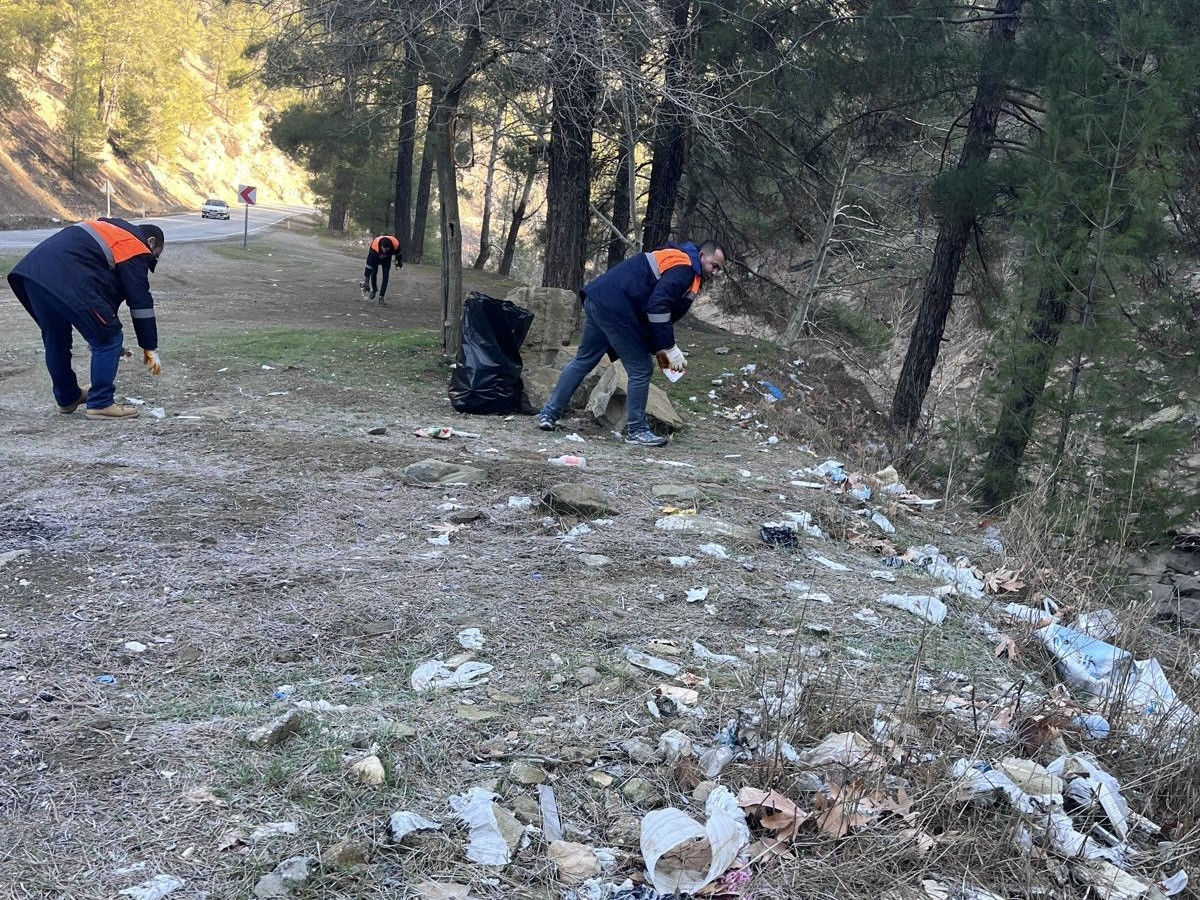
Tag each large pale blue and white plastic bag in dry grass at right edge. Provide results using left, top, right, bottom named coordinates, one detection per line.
left=1036, top=623, right=1196, bottom=737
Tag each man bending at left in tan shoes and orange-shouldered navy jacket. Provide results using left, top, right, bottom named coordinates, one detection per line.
left=8, top=218, right=163, bottom=419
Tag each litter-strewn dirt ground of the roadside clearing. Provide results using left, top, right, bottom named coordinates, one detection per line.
left=0, top=229, right=1195, bottom=900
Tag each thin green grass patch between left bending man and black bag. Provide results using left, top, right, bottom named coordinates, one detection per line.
left=176, top=328, right=445, bottom=383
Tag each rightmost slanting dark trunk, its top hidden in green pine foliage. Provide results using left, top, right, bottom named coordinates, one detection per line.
left=980, top=283, right=1070, bottom=508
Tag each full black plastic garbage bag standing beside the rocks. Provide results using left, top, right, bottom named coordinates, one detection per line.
left=450, top=292, right=533, bottom=415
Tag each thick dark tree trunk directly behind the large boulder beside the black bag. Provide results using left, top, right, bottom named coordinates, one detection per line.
left=541, top=5, right=598, bottom=290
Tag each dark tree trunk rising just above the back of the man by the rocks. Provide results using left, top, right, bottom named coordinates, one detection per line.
left=642, top=0, right=694, bottom=251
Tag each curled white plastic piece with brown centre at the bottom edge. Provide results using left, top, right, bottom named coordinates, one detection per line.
left=641, top=787, right=750, bottom=894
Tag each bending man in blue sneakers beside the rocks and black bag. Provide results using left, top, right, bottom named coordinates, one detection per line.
left=538, top=241, right=725, bottom=446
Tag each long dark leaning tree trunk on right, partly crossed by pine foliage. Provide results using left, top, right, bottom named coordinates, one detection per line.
left=892, top=0, right=1024, bottom=437
